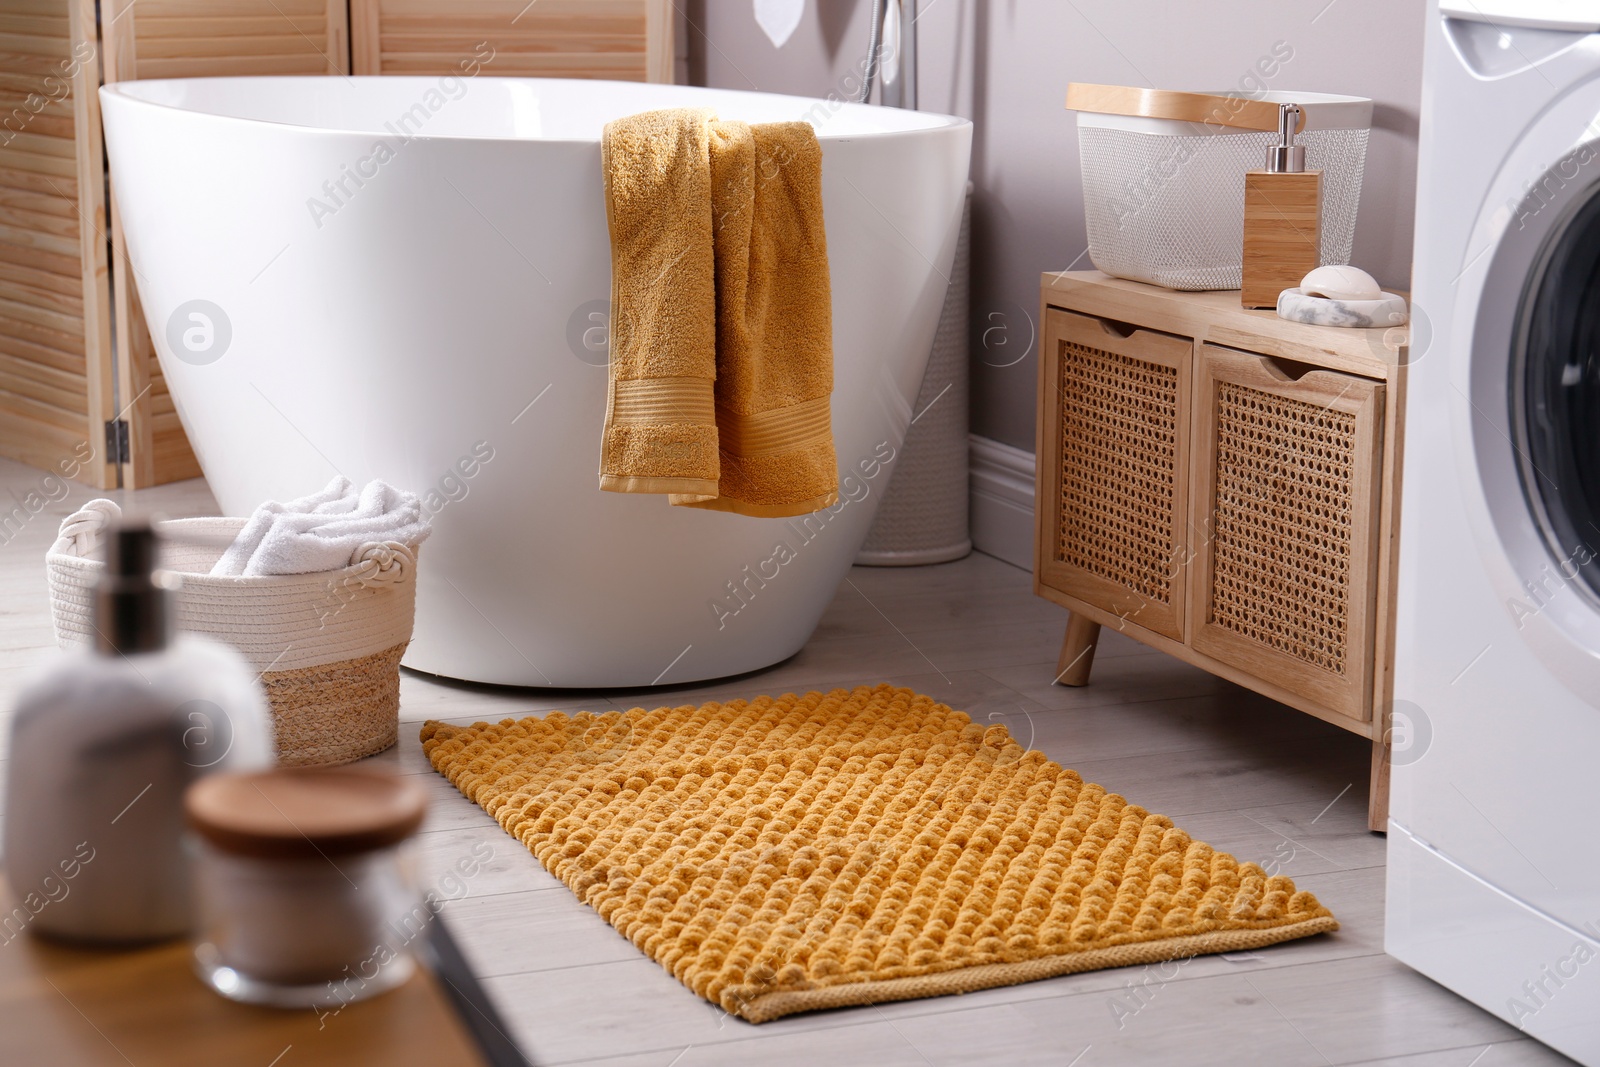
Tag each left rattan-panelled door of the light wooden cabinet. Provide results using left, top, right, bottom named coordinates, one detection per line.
left=1037, top=309, right=1194, bottom=641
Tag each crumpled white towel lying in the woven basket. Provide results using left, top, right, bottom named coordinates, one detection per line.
left=211, top=477, right=430, bottom=576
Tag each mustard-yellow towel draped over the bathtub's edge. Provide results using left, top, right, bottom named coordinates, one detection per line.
left=600, top=109, right=838, bottom=517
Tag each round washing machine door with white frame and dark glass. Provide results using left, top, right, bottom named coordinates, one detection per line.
left=1464, top=125, right=1600, bottom=707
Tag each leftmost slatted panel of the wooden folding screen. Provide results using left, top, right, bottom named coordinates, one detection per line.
left=0, top=0, right=117, bottom=489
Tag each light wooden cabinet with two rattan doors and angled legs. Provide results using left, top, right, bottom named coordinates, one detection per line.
left=1034, top=272, right=1405, bottom=829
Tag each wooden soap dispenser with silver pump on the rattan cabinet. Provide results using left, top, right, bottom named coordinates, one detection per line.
left=1240, top=104, right=1322, bottom=307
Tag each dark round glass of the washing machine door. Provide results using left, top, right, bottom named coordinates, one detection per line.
left=1509, top=194, right=1600, bottom=603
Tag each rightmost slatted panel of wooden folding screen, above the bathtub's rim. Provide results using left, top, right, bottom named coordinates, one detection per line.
left=350, top=0, right=674, bottom=82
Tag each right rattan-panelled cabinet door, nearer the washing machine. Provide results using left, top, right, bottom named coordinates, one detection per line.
left=1189, top=344, right=1384, bottom=720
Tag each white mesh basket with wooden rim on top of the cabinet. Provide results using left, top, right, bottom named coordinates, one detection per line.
left=1067, top=85, right=1373, bottom=290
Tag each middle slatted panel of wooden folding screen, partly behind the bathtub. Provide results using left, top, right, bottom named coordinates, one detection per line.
left=101, top=0, right=350, bottom=488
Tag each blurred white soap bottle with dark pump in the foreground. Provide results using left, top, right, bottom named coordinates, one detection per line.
left=0, top=522, right=272, bottom=944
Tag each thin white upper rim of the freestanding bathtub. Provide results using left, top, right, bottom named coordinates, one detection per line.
left=99, top=74, right=973, bottom=147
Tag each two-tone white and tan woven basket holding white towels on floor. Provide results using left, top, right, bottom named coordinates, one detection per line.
left=46, top=486, right=427, bottom=766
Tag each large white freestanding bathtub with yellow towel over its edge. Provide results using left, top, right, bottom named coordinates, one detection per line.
left=101, top=77, right=971, bottom=688
